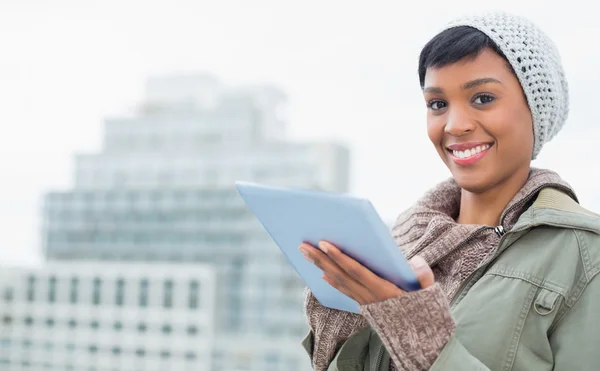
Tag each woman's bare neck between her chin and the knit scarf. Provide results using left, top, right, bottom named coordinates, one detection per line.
left=456, top=168, right=529, bottom=226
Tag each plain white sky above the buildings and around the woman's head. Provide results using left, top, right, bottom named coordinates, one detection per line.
left=0, top=0, right=600, bottom=264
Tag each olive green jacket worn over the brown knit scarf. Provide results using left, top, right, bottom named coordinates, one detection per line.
left=303, top=188, right=600, bottom=371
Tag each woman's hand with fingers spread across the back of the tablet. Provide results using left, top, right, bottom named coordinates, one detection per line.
left=298, top=241, right=434, bottom=305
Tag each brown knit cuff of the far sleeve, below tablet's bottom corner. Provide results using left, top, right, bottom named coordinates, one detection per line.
left=302, top=288, right=368, bottom=371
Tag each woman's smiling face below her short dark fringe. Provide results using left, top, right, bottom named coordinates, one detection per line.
left=423, top=49, right=533, bottom=193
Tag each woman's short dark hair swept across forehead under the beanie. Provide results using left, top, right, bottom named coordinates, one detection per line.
left=419, top=26, right=514, bottom=88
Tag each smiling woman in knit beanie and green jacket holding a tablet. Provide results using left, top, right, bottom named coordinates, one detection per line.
left=299, top=13, right=600, bottom=371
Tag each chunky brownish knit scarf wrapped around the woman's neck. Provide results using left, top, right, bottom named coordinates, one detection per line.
left=392, top=168, right=577, bottom=300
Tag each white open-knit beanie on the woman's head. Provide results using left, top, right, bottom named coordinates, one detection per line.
left=445, top=13, right=569, bottom=159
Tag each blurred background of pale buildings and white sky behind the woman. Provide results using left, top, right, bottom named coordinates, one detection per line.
left=0, top=0, right=600, bottom=371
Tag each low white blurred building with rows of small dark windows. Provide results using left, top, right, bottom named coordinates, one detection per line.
left=0, top=261, right=215, bottom=371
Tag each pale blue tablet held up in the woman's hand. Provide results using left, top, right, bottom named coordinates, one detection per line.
left=236, top=182, right=420, bottom=313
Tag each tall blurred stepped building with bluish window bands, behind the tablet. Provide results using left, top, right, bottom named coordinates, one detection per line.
left=34, top=75, right=349, bottom=371
